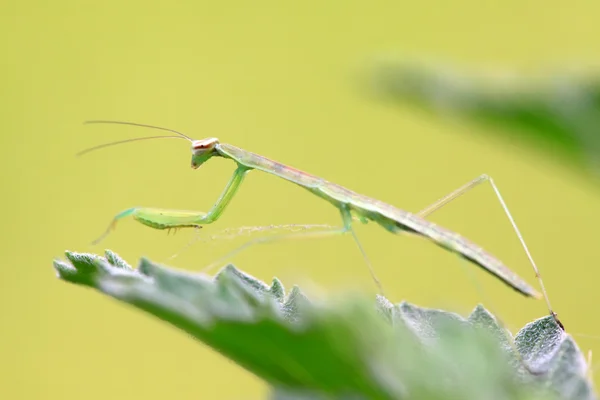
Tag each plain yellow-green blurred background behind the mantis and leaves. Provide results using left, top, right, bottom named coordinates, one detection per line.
left=0, top=0, right=600, bottom=400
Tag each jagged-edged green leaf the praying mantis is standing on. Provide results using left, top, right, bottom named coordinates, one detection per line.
left=54, top=251, right=595, bottom=400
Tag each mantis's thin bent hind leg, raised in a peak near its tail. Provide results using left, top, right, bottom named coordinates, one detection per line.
left=417, top=174, right=565, bottom=330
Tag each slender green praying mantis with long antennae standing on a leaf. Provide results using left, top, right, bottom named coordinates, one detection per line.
left=79, top=120, right=564, bottom=329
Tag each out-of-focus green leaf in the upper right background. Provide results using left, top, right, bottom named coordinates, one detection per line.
left=374, top=62, right=600, bottom=177
